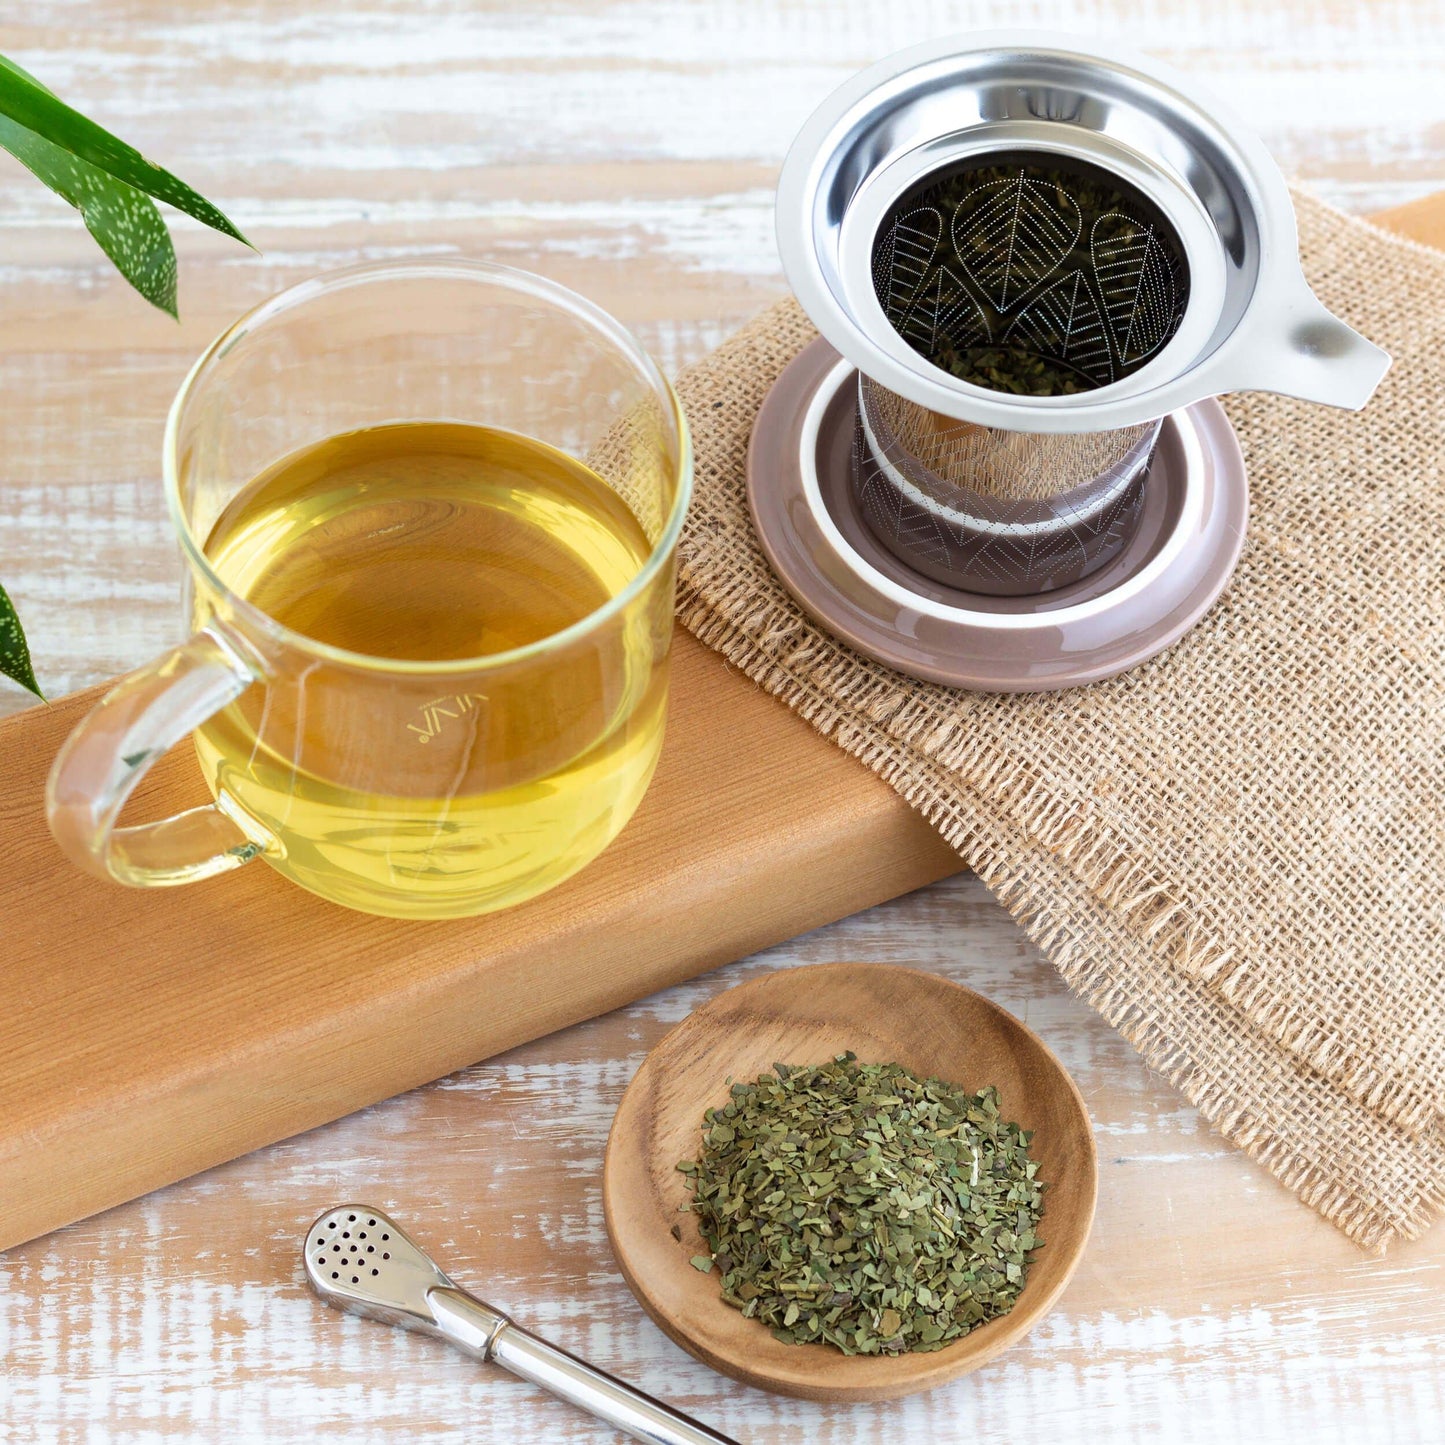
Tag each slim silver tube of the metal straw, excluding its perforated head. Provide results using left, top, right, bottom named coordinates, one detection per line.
left=426, top=1286, right=737, bottom=1445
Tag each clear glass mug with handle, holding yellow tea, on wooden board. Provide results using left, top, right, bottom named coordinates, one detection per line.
left=48, top=260, right=692, bottom=918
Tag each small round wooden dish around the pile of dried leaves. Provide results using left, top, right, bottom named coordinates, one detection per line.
left=603, top=964, right=1098, bottom=1400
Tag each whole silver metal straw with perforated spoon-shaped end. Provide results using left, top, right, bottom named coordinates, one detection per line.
left=302, top=1204, right=736, bottom=1445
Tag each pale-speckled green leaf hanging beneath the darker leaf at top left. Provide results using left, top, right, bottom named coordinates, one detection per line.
left=0, top=116, right=176, bottom=316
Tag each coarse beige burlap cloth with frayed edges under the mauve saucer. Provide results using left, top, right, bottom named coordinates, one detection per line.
left=678, top=195, right=1445, bottom=1248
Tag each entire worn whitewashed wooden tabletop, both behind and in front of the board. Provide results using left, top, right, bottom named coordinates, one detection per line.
left=0, top=0, right=1445, bottom=1445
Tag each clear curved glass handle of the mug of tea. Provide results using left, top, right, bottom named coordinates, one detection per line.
left=45, top=629, right=262, bottom=887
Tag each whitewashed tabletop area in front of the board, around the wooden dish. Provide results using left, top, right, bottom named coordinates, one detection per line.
left=0, top=877, right=1445, bottom=1445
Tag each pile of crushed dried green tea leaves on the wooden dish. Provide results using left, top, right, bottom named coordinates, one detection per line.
left=678, top=1053, right=1043, bottom=1354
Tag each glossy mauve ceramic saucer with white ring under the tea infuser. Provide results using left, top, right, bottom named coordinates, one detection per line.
left=747, top=341, right=1248, bottom=692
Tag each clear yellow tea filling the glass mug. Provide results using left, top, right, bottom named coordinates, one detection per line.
left=197, top=422, right=672, bottom=918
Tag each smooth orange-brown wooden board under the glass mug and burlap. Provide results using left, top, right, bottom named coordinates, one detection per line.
left=0, top=197, right=1445, bottom=1248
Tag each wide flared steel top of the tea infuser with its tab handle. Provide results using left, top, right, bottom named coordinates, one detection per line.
left=777, top=32, right=1389, bottom=434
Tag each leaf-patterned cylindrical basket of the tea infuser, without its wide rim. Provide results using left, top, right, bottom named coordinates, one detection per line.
left=854, top=152, right=1189, bottom=594
